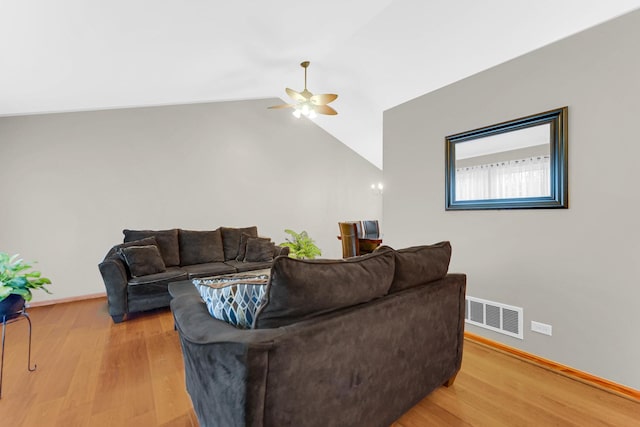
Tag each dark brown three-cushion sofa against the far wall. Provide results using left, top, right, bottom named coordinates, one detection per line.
left=98, top=226, right=289, bottom=323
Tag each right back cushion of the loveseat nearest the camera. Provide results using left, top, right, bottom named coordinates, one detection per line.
left=388, top=242, right=451, bottom=293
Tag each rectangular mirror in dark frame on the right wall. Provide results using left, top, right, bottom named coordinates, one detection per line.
left=445, top=107, right=569, bottom=210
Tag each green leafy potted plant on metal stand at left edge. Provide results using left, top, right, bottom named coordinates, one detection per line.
left=0, top=252, right=51, bottom=318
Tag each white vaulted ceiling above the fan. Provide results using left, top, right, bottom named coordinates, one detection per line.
left=0, top=0, right=640, bottom=167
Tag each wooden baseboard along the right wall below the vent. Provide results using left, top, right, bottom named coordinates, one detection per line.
left=464, top=332, right=640, bottom=401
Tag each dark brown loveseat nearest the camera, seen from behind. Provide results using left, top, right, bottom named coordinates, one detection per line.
left=171, top=242, right=466, bottom=427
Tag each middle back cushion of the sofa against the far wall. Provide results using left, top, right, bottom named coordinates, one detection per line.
left=178, top=228, right=224, bottom=266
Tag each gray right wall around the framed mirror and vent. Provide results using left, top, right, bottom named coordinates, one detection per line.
left=383, top=11, right=640, bottom=389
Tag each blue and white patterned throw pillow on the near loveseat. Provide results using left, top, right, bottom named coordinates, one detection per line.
left=193, top=270, right=269, bottom=329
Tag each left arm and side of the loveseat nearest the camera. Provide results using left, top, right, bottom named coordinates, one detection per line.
left=171, top=294, right=283, bottom=427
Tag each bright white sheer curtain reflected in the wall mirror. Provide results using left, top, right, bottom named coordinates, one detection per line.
left=456, top=155, right=551, bottom=200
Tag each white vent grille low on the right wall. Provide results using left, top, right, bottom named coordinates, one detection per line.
left=464, top=296, right=524, bottom=339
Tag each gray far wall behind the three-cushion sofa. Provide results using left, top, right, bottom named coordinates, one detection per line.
left=0, top=99, right=382, bottom=302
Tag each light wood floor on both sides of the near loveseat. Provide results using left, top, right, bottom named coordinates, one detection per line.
left=0, top=298, right=640, bottom=427
